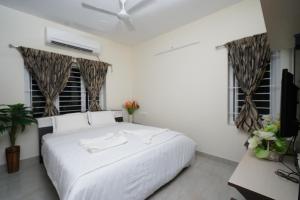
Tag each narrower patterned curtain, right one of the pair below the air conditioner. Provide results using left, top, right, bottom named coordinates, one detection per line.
left=77, top=58, right=110, bottom=111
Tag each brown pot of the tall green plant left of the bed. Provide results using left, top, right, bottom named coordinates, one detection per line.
left=5, top=146, right=20, bottom=173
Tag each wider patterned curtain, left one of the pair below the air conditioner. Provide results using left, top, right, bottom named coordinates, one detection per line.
left=18, top=47, right=72, bottom=116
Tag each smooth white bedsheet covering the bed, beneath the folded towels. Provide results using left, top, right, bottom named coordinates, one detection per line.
left=42, top=123, right=196, bottom=200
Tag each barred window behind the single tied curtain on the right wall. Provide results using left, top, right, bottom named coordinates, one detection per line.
left=229, top=59, right=272, bottom=124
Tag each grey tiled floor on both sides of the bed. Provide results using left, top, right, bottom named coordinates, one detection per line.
left=0, top=154, right=244, bottom=200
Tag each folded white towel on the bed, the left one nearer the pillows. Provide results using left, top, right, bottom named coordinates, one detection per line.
left=79, top=133, right=128, bottom=153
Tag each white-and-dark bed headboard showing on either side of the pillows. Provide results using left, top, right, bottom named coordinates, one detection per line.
left=37, top=110, right=123, bottom=163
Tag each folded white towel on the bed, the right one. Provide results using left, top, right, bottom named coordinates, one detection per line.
left=122, top=129, right=168, bottom=144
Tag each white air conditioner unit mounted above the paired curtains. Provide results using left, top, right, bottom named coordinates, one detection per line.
left=46, top=27, right=101, bottom=55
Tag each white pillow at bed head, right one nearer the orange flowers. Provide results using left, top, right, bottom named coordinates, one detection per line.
left=88, top=111, right=116, bottom=126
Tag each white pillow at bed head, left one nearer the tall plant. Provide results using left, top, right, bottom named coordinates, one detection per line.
left=52, top=113, right=90, bottom=133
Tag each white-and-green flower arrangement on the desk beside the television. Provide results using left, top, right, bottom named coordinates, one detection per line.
left=248, top=115, right=288, bottom=161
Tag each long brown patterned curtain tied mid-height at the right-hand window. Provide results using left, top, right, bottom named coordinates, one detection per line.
left=225, top=33, right=271, bottom=132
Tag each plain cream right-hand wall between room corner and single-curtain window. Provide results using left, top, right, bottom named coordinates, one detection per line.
left=133, top=0, right=266, bottom=161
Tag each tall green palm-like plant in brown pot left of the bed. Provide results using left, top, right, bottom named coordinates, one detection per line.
left=0, top=104, right=36, bottom=173
